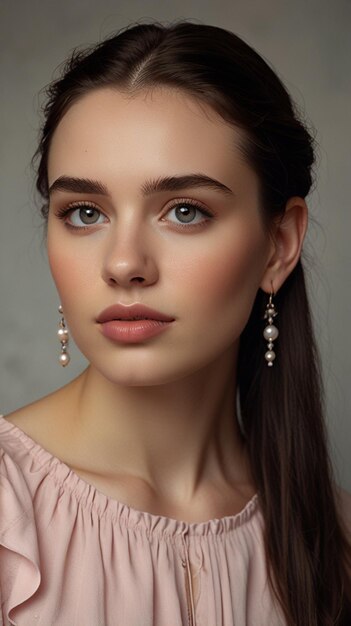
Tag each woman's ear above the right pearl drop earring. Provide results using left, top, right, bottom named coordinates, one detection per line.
left=260, top=196, right=308, bottom=293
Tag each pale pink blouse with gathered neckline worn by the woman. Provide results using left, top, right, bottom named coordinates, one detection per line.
left=0, top=415, right=351, bottom=626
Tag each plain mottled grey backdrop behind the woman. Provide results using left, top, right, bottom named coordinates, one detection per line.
left=0, top=0, right=351, bottom=491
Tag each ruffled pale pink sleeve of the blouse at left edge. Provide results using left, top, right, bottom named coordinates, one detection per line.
left=0, top=448, right=41, bottom=626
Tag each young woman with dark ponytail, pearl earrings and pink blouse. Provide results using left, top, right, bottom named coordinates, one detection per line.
left=0, top=22, right=351, bottom=626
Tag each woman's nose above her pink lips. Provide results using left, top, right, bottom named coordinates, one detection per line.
left=102, top=219, right=158, bottom=287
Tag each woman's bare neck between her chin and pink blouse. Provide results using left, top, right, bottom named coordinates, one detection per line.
left=66, top=344, right=253, bottom=501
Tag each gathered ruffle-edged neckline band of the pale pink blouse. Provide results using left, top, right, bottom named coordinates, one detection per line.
left=0, top=414, right=259, bottom=535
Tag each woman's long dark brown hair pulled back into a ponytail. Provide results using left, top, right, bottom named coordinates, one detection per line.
left=35, top=21, right=351, bottom=626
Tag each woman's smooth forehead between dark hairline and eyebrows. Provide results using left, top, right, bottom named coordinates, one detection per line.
left=48, top=89, right=256, bottom=191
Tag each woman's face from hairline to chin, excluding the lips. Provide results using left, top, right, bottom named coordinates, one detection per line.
left=47, top=88, right=272, bottom=385
